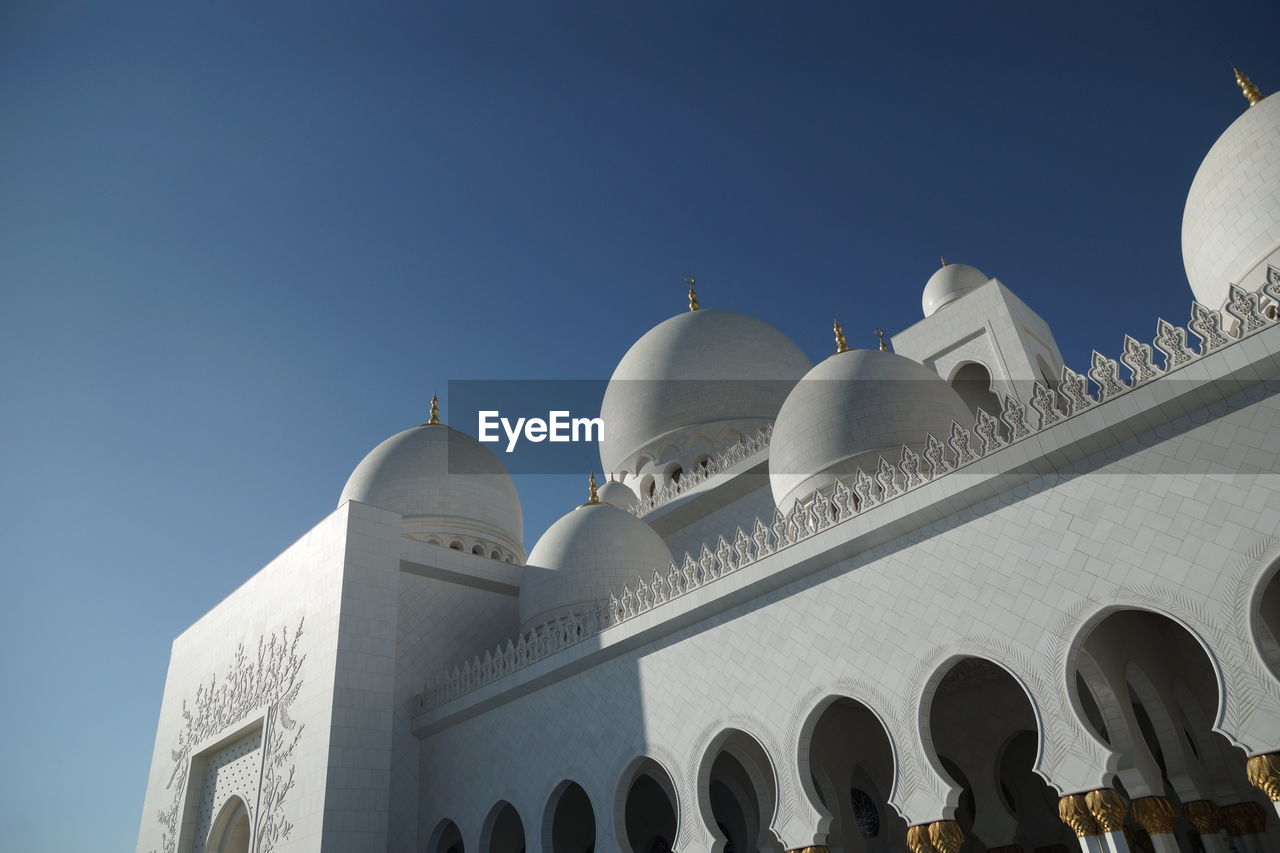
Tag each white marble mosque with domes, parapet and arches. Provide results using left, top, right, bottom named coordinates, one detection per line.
left=137, top=76, right=1280, bottom=853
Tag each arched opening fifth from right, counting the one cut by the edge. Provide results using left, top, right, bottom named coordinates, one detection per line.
left=699, top=730, right=782, bottom=853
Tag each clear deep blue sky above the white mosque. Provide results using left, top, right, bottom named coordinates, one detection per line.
left=0, top=0, right=1280, bottom=852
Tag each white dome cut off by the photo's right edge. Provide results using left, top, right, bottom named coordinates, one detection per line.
left=1183, top=96, right=1280, bottom=309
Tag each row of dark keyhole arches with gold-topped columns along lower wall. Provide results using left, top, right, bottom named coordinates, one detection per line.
left=428, top=601, right=1280, bottom=853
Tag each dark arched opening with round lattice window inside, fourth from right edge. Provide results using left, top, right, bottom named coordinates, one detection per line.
left=801, top=698, right=906, bottom=853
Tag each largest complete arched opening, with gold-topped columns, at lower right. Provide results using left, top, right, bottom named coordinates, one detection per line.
left=1073, top=610, right=1266, bottom=853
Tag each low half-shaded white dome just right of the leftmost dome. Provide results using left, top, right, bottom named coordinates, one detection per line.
left=520, top=499, right=672, bottom=631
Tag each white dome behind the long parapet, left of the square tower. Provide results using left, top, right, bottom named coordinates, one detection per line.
left=769, top=350, right=973, bottom=512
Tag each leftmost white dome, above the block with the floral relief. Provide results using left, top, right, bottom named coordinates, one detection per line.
left=338, top=424, right=525, bottom=562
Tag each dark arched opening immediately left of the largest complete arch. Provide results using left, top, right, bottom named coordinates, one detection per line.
left=928, top=657, right=1075, bottom=853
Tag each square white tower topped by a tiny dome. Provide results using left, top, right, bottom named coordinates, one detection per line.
left=893, top=259, right=1062, bottom=415
